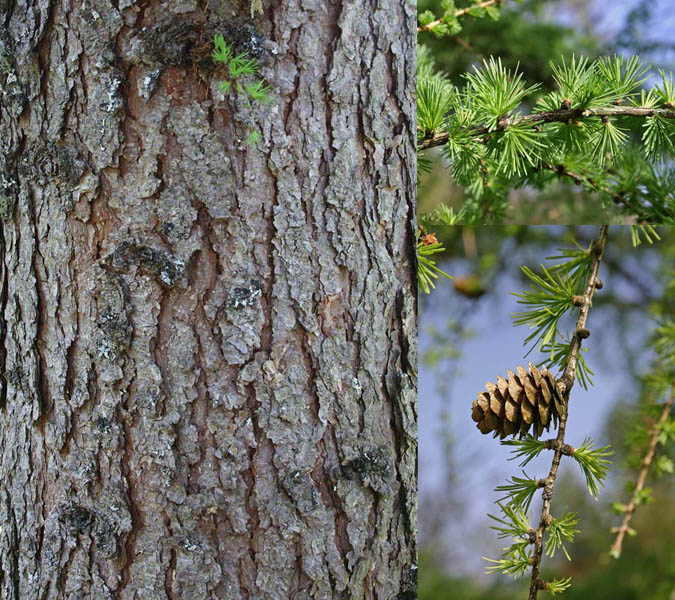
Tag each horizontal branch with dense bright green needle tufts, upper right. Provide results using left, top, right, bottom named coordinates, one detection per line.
left=417, top=46, right=675, bottom=223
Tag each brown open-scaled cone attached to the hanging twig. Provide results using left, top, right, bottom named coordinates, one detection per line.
left=471, top=362, right=562, bottom=439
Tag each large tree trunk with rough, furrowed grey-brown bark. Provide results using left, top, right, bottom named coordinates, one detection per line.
left=0, top=0, right=417, bottom=600
